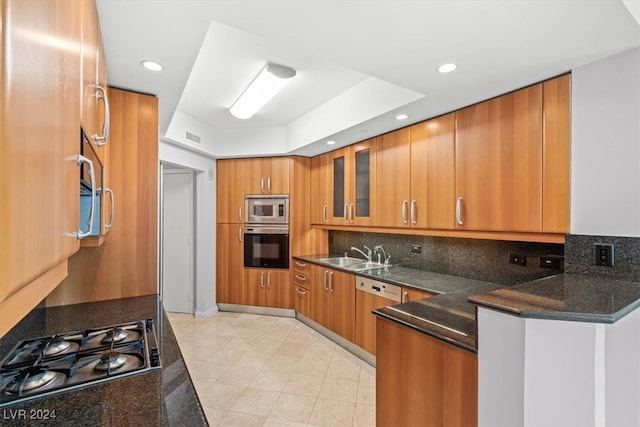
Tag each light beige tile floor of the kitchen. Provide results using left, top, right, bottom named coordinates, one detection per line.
left=168, top=312, right=376, bottom=427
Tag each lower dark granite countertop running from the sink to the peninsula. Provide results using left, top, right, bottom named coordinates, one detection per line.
left=294, top=254, right=503, bottom=353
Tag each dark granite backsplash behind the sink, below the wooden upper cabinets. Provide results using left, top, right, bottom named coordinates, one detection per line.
left=329, top=231, right=565, bottom=285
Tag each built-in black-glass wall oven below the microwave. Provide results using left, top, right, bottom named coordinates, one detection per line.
left=244, top=225, right=289, bottom=268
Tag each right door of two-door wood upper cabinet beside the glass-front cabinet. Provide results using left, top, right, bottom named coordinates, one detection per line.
left=412, top=113, right=455, bottom=230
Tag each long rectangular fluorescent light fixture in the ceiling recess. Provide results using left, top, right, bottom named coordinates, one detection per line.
left=229, top=63, right=296, bottom=119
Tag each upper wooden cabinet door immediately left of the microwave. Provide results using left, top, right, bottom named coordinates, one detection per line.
left=216, top=159, right=245, bottom=224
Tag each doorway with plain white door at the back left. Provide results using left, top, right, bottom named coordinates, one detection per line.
left=161, top=165, right=195, bottom=314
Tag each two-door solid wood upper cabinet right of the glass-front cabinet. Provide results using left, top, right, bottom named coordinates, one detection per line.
left=375, top=113, right=455, bottom=230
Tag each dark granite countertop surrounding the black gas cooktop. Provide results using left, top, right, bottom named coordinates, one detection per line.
left=0, top=295, right=207, bottom=426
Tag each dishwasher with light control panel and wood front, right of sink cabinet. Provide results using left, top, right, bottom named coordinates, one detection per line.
left=356, top=276, right=402, bottom=355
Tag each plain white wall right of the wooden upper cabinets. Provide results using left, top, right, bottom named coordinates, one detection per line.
left=571, top=48, right=640, bottom=237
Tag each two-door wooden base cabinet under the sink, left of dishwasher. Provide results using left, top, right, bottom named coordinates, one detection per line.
left=311, top=265, right=355, bottom=342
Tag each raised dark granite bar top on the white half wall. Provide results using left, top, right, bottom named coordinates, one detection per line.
left=469, top=274, right=640, bottom=323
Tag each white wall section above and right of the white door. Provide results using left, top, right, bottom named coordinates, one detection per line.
left=158, top=141, right=218, bottom=317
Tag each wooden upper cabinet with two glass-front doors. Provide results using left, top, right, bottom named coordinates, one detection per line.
left=327, top=138, right=376, bottom=226
